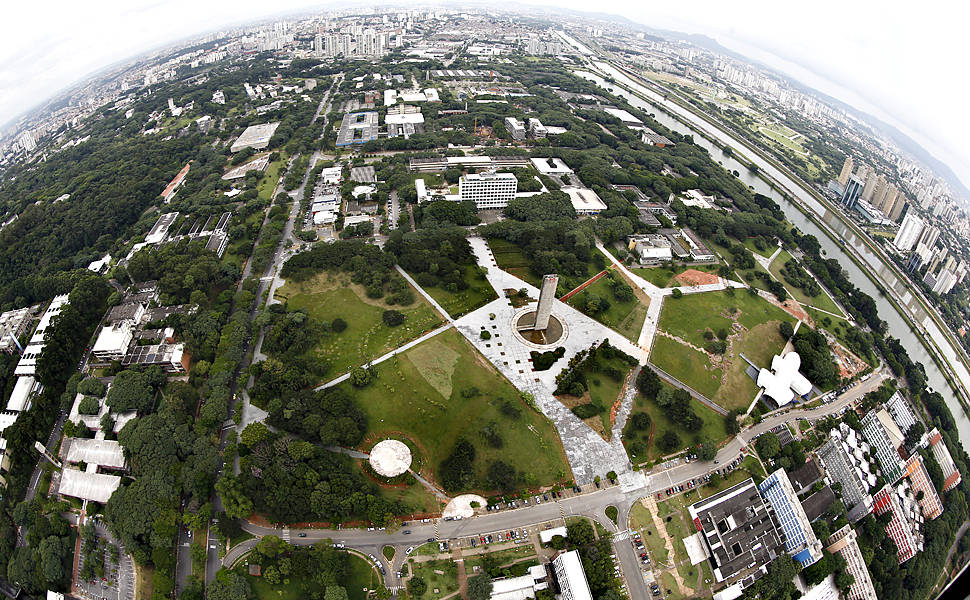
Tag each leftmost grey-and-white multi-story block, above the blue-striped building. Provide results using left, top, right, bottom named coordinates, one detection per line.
left=818, top=423, right=876, bottom=523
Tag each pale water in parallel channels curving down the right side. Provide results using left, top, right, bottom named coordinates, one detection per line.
left=576, top=62, right=970, bottom=444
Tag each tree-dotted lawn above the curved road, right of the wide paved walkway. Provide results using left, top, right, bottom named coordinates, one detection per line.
left=623, top=384, right=727, bottom=464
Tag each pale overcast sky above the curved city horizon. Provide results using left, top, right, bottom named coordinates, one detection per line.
left=0, top=0, right=970, bottom=186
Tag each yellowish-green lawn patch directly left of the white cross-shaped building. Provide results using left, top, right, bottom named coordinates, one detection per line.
left=711, top=321, right=785, bottom=410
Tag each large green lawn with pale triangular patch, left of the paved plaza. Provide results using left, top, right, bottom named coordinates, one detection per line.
left=341, top=329, right=570, bottom=486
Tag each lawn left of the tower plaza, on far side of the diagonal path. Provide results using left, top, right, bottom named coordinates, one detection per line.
left=276, top=272, right=442, bottom=377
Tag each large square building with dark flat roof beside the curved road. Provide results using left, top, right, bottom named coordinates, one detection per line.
left=687, top=479, right=784, bottom=582
